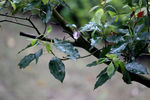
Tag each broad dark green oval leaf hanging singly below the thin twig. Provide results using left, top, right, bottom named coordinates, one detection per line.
left=49, top=57, right=65, bottom=82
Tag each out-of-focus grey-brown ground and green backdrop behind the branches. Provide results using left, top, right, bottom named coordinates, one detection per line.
left=0, top=0, right=150, bottom=100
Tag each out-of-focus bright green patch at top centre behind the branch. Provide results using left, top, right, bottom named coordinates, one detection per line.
left=60, top=0, right=99, bottom=26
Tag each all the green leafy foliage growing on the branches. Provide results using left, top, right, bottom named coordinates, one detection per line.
left=1, top=0, right=150, bottom=89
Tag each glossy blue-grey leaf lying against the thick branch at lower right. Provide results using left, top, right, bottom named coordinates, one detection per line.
left=125, top=62, right=148, bottom=74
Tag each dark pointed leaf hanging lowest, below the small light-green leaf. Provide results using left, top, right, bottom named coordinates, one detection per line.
left=94, top=73, right=109, bottom=89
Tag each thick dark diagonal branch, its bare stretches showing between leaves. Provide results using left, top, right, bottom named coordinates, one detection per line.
left=53, top=9, right=150, bottom=88
